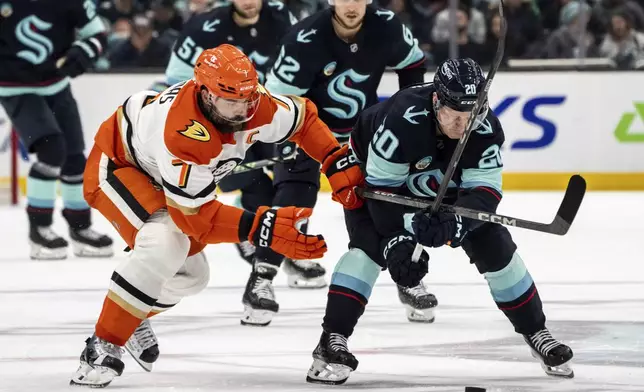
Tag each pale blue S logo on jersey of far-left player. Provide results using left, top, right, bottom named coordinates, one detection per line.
left=16, top=15, right=54, bottom=65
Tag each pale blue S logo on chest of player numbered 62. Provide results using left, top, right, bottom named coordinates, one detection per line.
left=324, top=69, right=369, bottom=119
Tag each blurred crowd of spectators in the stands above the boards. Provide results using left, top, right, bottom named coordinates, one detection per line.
left=97, top=0, right=644, bottom=70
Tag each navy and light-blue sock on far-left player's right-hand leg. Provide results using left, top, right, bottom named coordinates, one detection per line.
left=60, top=154, right=91, bottom=230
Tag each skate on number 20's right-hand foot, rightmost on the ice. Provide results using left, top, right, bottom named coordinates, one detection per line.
left=523, top=328, right=575, bottom=378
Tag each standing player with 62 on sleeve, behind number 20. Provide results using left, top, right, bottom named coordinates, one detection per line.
left=257, top=0, right=437, bottom=322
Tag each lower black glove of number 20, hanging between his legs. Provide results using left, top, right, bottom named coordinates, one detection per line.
left=382, top=234, right=429, bottom=287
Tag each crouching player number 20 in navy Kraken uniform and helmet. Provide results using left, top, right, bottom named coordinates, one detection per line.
left=307, top=59, right=573, bottom=384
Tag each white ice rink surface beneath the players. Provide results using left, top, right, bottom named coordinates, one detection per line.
left=0, top=192, right=644, bottom=392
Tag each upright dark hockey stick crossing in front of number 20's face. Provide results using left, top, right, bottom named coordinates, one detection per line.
left=411, top=0, right=508, bottom=262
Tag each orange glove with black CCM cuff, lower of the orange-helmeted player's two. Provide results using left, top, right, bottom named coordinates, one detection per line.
left=248, top=206, right=327, bottom=260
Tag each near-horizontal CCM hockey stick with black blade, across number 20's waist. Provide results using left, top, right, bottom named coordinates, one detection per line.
left=356, top=174, right=586, bottom=235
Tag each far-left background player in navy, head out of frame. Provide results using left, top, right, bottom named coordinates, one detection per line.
left=0, top=0, right=113, bottom=259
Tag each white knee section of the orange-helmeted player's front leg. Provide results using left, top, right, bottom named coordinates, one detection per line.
left=115, top=210, right=190, bottom=300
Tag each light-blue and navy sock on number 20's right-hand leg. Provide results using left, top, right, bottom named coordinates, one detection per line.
left=483, top=252, right=546, bottom=335
